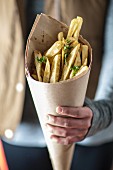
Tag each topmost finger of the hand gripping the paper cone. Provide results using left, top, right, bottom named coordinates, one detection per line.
left=56, top=106, right=92, bottom=118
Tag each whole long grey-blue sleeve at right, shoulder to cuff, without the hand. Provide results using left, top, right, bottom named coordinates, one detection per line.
left=85, top=0, right=113, bottom=136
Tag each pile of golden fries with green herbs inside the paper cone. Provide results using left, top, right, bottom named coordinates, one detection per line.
left=32, top=17, right=88, bottom=83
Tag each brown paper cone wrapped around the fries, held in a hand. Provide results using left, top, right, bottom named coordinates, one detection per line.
left=25, top=14, right=92, bottom=170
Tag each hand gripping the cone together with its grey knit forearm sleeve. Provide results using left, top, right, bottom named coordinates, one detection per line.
left=47, top=99, right=113, bottom=145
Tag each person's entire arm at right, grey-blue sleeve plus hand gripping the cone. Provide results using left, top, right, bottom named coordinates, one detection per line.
left=47, top=1, right=113, bottom=144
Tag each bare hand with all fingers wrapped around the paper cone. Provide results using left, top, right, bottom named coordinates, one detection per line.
left=46, top=106, right=93, bottom=145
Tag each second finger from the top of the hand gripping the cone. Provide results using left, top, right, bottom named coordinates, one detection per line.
left=47, top=115, right=91, bottom=129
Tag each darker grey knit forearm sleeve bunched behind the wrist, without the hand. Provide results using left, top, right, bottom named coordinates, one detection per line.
left=84, top=98, right=113, bottom=137
